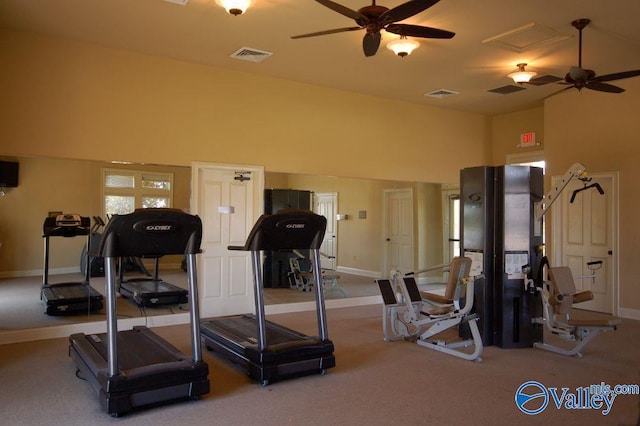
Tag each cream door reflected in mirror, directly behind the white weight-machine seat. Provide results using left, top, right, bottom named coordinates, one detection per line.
left=384, top=189, right=413, bottom=275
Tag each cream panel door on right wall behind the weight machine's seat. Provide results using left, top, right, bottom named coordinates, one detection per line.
left=554, top=174, right=617, bottom=313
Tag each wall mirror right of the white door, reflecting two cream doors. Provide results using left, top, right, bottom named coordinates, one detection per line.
left=265, top=172, right=457, bottom=304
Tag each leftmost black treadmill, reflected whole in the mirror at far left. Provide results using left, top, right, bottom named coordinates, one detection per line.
left=40, top=214, right=103, bottom=315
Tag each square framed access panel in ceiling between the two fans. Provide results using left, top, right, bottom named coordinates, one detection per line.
left=482, top=22, right=572, bottom=53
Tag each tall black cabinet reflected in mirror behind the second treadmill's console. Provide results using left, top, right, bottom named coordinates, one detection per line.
left=263, top=189, right=313, bottom=288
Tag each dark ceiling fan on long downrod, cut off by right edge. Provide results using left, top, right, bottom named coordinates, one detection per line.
left=564, top=18, right=640, bottom=93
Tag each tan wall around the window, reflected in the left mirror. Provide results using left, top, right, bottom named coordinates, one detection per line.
left=0, top=157, right=191, bottom=276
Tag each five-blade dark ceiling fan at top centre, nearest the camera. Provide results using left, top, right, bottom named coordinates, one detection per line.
left=291, top=0, right=455, bottom=56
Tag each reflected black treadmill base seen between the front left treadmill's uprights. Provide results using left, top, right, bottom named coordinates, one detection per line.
left=119, top=279, right=189, bottom=308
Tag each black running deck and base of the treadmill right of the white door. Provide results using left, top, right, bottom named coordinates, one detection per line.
left=200, top=315, right=336, bottom=386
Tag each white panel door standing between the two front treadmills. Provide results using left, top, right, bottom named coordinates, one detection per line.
left=191, top=163, right=264, bottom=317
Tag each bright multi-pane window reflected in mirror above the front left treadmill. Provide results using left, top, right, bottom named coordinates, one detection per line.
left=103, top=169, right=173, bottom=217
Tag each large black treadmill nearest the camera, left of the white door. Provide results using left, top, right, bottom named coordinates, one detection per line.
left=69, top=208, right=209, bottom=417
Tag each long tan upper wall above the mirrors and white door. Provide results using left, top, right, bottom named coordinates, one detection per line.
left=0, top=30, right=490, bottom=183
